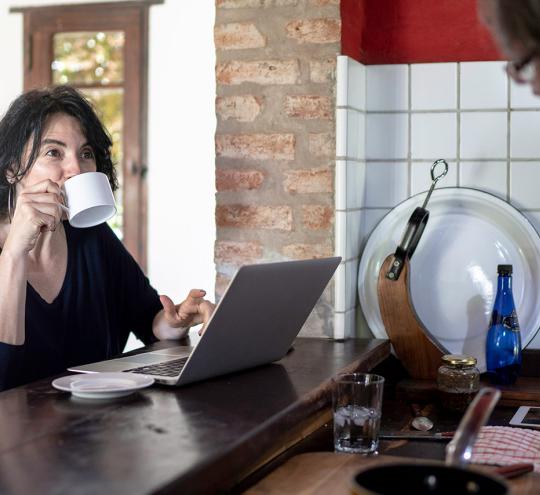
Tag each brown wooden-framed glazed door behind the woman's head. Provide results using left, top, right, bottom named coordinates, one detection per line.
left=11, top=0, right=163, bottom=269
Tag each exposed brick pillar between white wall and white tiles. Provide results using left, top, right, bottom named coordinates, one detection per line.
left=215, top=0, right=341, bottom=336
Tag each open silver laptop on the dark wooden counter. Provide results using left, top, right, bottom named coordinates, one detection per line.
left=68, top=257, right=341, bottom=385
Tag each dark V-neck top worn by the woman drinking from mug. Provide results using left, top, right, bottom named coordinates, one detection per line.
left=0, top=222, right=162, bottom=390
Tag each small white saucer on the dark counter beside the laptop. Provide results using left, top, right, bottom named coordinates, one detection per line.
left=52, top=373, right=154, bottom=399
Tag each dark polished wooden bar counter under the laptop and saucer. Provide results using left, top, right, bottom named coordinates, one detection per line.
left=0, top=338, right=390, bottom=495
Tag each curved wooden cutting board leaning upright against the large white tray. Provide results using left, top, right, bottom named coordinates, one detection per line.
left=377, top=255, right=443, bottom=380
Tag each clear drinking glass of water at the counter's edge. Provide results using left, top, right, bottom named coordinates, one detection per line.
left=332, top=373, right=384, bottom=454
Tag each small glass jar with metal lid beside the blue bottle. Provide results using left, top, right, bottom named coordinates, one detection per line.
left=437, top=354, right=480, bottom=411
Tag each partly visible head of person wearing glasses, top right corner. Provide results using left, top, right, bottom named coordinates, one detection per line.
left=478, top=0, right=540, bottom=96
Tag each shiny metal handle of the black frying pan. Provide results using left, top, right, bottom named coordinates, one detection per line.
left=445, top=387, right=501, bottom=467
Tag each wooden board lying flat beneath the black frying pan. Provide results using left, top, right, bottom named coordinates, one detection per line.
left=244, top=452, right=540, bottom=495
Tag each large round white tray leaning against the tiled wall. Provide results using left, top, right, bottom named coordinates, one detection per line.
left=358, top=187, right=540, bottom=372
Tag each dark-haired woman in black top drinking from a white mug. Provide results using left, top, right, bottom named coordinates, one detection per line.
left=0, top=86, right=214, bottom=389
